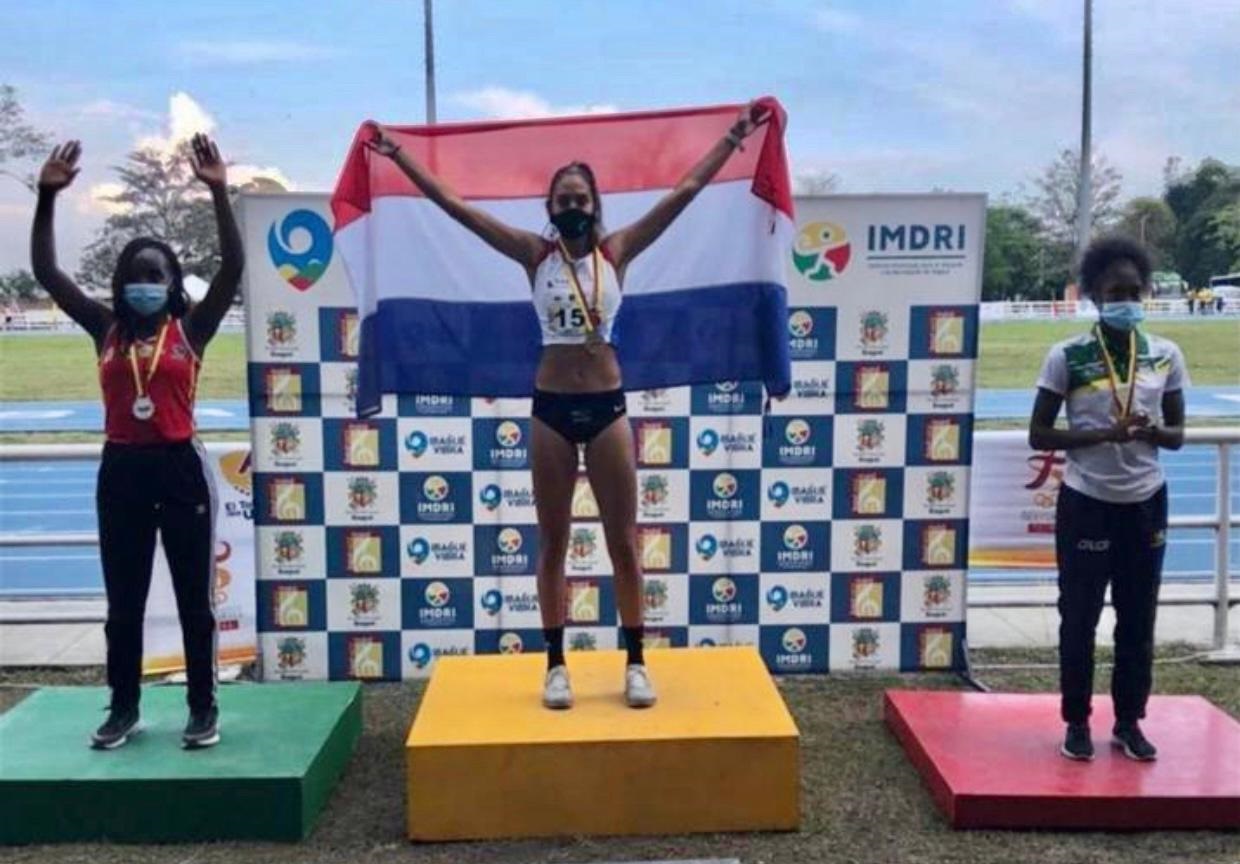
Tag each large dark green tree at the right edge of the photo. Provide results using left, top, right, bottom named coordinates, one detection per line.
left=1163, top=159, right=1240, bottom=286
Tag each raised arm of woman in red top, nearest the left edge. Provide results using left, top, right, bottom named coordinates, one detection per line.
left=30, top=141, right=112, bottom=350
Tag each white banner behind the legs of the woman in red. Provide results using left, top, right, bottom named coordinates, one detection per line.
left=143, top=443, right=258, bottom=674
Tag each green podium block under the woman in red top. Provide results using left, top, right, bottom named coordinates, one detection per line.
left=0, top=683, right=362, bottom=844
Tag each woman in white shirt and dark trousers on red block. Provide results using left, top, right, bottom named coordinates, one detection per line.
left=1029, top=238, right=1188, bottom=761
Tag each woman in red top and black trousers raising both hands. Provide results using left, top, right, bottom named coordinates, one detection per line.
left=31, top=135, right=243, bottom=750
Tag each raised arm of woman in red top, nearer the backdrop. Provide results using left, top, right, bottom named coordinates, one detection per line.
left=185, top=134, right=246, bottom=356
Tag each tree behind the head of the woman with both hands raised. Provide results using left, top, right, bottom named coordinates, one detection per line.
left=77, top=141, right=231, bottom=293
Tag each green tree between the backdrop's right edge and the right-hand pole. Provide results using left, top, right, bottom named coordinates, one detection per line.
left=982, top=205, right=1070, bottom=301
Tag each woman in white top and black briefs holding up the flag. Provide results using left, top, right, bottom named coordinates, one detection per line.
left=370, top=103, right=766, bottom=708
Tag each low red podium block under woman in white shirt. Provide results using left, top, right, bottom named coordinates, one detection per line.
left=883, top=690, right=1240, bottom=831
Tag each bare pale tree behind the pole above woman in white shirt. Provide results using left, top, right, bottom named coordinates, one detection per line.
left=1029, top=150, right=1122, bottom=249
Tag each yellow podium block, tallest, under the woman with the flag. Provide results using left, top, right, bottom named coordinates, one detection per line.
left=405, top=648, right=800, bottom=840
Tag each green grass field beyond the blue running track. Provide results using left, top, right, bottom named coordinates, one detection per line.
left=0, top=317, right=1240, bottom=402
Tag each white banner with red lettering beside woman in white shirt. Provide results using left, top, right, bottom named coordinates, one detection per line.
left=968, top=428, right=1064, bottom=569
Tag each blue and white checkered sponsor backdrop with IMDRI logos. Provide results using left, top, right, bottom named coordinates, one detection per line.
left=242, top=195, right=985, bottom=679
